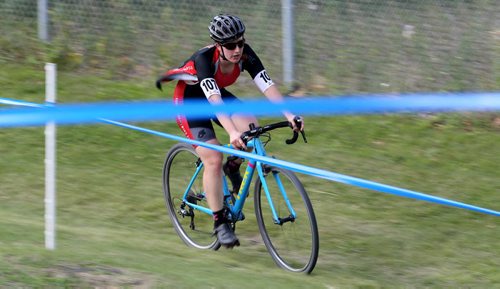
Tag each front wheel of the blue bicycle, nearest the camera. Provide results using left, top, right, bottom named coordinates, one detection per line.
left=254, top=167, right=319, bottom=274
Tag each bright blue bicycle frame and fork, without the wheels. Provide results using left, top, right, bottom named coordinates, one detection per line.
left=183, top=137, right=296, bottom=225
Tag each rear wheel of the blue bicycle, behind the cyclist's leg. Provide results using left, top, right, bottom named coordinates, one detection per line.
left=163, top=143, right=220, bottom=249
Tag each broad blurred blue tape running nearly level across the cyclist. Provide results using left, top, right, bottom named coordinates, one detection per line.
left=0, top=92, right=500, bottom=127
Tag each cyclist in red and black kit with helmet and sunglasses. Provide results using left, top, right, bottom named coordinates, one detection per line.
left=156, top=14, right=303, bottom=248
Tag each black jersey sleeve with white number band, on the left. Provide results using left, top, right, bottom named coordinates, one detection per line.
left=194, top=50, right=220, bottom=98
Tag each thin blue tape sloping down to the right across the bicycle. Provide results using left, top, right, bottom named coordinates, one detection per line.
left=2, top=95, right=500, bottom=217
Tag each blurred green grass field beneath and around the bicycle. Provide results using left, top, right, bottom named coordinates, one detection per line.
left=0, top=65, right=500, bottom=289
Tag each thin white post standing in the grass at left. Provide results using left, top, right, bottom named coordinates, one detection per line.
left=45, top=63, right=57, bottom=250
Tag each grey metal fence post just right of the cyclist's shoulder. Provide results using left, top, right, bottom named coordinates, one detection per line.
left=281, top=0, right=295, bottom=88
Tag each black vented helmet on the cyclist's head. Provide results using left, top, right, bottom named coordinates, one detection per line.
left=208, top=14, right=245, bottom=43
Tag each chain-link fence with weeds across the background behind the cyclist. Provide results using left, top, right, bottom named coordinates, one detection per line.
left=0, top=0, right=500, bottom=93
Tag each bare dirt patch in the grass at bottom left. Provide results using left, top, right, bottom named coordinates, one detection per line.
left=47, top=264, right=155, bottom=289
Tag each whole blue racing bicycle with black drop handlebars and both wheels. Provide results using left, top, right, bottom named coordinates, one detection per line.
left=163, top=121, right=319, bottom=273
